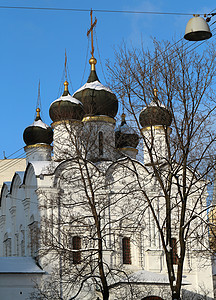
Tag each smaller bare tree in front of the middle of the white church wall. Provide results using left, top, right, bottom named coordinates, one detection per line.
left=32, top=118, right=146, bottom=299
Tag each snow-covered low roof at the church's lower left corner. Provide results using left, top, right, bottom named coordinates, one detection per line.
left=0, top=257, right=45, bottom=274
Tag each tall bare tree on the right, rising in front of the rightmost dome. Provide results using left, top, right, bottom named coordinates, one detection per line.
left=108, top=41, right=216, bottom=299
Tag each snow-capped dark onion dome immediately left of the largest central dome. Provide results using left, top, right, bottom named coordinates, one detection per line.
left=49, top=81, right=84, bottom=122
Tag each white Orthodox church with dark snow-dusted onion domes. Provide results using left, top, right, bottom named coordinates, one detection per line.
left=0, top=15, right=214, bottom=300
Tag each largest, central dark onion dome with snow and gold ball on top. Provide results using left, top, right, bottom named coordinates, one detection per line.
left=73, top=56, right=118, bottom=118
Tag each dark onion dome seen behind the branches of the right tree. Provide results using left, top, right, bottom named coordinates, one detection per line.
left=139, top=89, right=172, bottom=127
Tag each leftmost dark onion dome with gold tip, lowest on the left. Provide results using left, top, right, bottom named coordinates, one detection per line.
left=23, top=108, right=53, bottom=146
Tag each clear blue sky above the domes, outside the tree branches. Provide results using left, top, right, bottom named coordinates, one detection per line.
left=0, top=0, right=216, bottom=158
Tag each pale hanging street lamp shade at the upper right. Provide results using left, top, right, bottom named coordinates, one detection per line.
left=184, top=15, right=212, bottom=41
